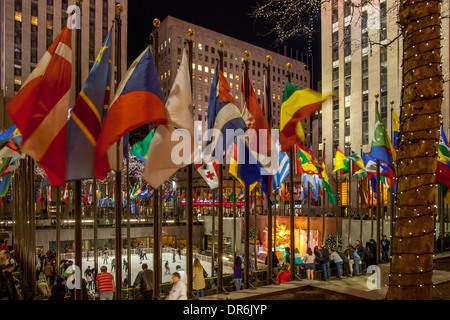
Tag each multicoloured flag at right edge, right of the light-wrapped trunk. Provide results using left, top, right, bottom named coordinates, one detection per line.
left=436, top=127, right=450, bottom=203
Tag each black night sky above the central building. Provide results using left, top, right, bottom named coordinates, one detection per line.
left=128, top=0, right=321, bottom=88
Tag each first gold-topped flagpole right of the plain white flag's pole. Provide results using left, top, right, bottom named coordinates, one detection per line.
left=217, top=41, right=225, bottom=294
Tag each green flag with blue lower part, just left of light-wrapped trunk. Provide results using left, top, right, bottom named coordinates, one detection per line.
left=370, top=108, right=397, bottom=175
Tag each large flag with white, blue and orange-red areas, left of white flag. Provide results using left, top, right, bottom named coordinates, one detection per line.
left=94, top=48, right=167, bottom=180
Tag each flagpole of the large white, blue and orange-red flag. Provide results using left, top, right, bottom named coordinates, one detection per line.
left=152, top=19, right=162, bottom=300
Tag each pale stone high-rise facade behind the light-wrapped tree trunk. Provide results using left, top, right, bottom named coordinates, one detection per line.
left=321, top=0, right=449, bottom=211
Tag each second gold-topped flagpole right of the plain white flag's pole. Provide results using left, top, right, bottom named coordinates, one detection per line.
left=244, top=50, right=253, bottom=289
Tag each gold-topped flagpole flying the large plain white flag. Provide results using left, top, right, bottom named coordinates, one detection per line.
left=186, top=29, right=194, bottom=297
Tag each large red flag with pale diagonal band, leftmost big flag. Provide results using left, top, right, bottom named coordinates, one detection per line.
left=7, top=27, right=72, bottom=186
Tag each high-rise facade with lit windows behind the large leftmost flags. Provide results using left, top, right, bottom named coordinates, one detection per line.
left=0, top=0, right=128, bottom=128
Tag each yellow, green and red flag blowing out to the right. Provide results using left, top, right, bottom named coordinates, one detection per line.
left=280, top=81, right=331, bottom=152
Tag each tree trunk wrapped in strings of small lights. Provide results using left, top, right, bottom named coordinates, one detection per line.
left=388, top=0, right=443, bottom=300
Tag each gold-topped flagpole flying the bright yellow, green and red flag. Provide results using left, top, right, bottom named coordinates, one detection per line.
left=286, top=62, right=298, bottom=281
